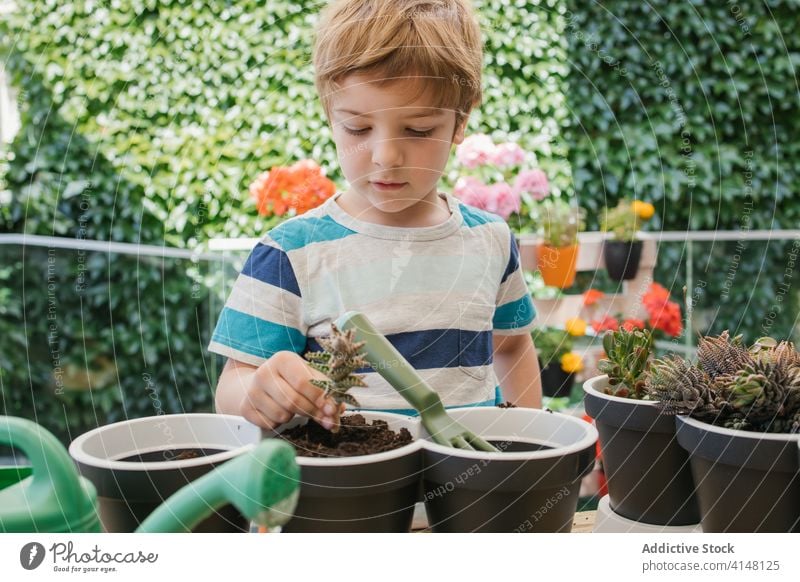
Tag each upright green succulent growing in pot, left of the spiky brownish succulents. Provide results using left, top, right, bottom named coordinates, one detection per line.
left=597, top=328, right=653, bottom=399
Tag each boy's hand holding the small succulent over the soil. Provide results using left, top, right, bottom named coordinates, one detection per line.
left=241, top=351, right=345, bottom=430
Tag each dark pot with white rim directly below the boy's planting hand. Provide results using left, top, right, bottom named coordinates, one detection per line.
left=273, top=411, right=422, bottom=533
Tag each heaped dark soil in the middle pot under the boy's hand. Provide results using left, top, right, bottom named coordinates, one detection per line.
left=280, top=414, right=413, bottom=458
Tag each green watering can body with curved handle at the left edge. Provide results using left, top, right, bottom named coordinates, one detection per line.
left=0, top=416, right=100, bottom=533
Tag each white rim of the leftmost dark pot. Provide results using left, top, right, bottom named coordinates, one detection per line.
left=69, top=412, right=258, bottom=471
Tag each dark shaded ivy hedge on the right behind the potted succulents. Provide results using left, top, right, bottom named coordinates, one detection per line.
left=564, top=0, right=800, bottom=341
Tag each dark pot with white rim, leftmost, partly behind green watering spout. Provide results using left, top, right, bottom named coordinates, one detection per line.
left=69, top=414, right=261, bottom=532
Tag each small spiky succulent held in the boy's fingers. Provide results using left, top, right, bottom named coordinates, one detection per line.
left=305, top=323, right=367, bottom=406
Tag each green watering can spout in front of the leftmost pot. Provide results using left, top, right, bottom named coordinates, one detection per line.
left=136, top=439, right=300, bottom=533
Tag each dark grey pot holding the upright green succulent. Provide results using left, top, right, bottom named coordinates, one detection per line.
left=583, top=376, right=700, bottom=526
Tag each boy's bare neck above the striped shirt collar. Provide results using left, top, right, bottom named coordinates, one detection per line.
left=333, top=189, right=451, bottom=228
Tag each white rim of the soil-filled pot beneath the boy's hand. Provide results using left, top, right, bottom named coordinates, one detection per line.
left=270, top=410, right=422, bottom=467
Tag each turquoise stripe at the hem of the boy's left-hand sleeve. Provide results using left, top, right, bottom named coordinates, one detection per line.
left=211, top=307, right=306, bottom=358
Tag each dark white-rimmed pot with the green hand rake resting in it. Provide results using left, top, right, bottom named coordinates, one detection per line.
left=423, top=407, right=597, bottom=532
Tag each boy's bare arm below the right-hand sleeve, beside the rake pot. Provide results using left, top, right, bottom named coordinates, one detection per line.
left=492, top=333, right=542, bottom=408
